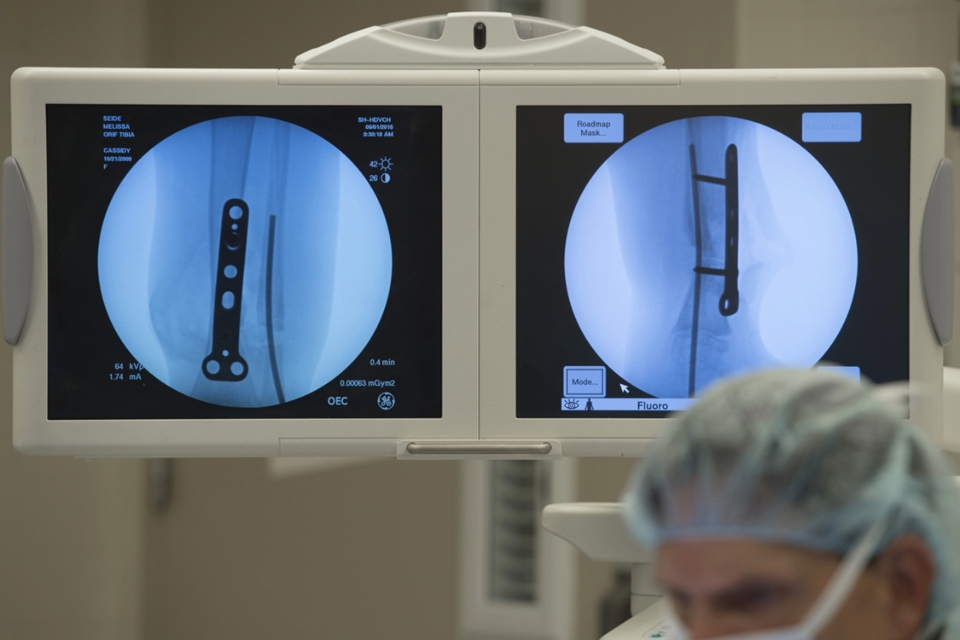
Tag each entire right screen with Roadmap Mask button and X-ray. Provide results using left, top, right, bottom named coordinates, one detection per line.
left=516, top=105, right=910, bottom=418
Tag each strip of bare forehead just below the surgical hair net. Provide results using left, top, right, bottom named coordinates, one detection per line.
left=657, top=538, right=839, bottom=591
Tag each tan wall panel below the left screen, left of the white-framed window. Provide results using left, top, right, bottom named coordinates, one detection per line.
left=144, top=459, right=459, bottom=640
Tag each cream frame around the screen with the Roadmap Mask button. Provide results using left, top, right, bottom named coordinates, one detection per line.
left=480, top=69, right=945, bottom=456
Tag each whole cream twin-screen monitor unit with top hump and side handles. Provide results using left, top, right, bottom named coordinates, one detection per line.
left=3, top=13, right=953, bottom=458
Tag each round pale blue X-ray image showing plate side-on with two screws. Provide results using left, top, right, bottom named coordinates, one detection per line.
left=564, top=116, right=858, bottom=398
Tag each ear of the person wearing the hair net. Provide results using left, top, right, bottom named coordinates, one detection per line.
left=876, top=533, right=936, bottom=638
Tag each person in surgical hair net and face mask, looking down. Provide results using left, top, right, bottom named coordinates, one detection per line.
left=624, top=370, right=960, bottom=640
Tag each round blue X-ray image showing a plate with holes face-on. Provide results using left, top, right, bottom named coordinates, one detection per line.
left=98, top=116, right=393, bottom=407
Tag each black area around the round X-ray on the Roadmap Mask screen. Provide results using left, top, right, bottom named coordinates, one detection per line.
left=516, top=105, right=910, bottom=419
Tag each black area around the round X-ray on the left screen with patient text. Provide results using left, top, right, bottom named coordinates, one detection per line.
left=47, top=105, right=442, bottom=420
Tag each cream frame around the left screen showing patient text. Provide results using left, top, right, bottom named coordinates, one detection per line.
left=11, top=68, right=479, bottom=457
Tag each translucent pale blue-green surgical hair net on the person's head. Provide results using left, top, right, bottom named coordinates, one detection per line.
left=623, top=370, right=960, bottom=623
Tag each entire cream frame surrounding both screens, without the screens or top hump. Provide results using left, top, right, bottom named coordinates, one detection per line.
left=12, top=68, right=945, bottom=459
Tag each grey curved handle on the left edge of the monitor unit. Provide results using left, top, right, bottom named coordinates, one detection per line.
left=0, top=156, right=33, bottom=344
